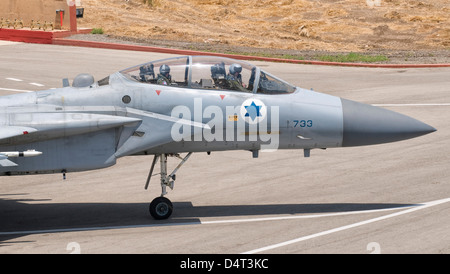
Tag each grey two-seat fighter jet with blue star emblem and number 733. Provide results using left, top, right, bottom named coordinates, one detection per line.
left=0, top=56, right=435, bottom=219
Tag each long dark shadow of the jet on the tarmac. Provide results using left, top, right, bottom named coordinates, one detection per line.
left=0, top=194, right=413, bottom=243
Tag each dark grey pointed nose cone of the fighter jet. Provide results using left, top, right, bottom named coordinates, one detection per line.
left=341, top=98, right=436, bottom=147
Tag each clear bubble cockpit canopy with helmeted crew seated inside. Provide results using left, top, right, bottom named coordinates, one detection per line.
left=120, top=56, right=296, bottom=94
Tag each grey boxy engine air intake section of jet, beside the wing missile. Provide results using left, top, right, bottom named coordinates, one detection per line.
left=0, top=106, right=142, bottom=171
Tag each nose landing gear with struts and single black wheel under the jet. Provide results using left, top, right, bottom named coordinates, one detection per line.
left=145, top=152, right=192, bottom=220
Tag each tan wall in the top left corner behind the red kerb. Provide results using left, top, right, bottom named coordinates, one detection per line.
left=0, top=0, right=70, bottom=30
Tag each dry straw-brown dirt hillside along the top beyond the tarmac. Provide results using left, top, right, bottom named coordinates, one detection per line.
left=78, top=0, right=450, bottom=52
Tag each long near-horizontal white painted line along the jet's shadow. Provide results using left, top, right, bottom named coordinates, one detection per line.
left=0, top=201, right=419, bottom=236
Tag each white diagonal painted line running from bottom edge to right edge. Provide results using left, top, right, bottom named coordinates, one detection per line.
left=242, top=198, right=450, bottom=254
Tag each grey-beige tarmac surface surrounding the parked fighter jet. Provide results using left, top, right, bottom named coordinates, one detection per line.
left=0, top=41, right=450, bottom=254
